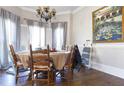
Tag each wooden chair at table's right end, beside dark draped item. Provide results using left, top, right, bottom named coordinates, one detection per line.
left=64, top=46, right=75, bottom=70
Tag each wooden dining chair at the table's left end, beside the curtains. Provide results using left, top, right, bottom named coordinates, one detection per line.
left=9, top=45, right=28, bottom=83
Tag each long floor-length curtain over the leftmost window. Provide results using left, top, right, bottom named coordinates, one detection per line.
left=0, top=9, right=20, bottom=68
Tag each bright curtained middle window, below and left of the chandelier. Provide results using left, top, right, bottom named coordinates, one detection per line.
left=27, top=20, right=46, bottom=49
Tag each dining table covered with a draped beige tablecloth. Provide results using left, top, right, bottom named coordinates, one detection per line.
left=16, top=51, right=70, bottom=71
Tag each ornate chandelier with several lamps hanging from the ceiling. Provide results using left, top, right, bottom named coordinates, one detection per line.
left=36, top=6, right=56, bottom=22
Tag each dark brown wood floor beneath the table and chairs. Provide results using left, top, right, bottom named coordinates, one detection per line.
left=0, top=68, right=124, bottom=86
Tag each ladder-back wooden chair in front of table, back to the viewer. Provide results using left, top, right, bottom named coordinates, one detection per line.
left=30, top=45, right=53, bottom=84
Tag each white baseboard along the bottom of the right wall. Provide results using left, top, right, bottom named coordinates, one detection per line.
left=92, top=62, right=124, bottom=79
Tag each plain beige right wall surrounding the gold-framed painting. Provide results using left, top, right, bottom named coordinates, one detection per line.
left=71, top=6, right=124, bottom=69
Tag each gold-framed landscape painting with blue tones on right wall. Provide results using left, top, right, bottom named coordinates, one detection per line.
left=92, top=6, right=124, bottom=43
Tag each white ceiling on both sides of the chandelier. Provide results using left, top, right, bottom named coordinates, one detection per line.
left=20, top=6, right=79, bottom=13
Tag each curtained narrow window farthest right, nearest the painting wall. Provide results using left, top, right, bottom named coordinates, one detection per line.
left=52, top=22, right=67, bottom=50
